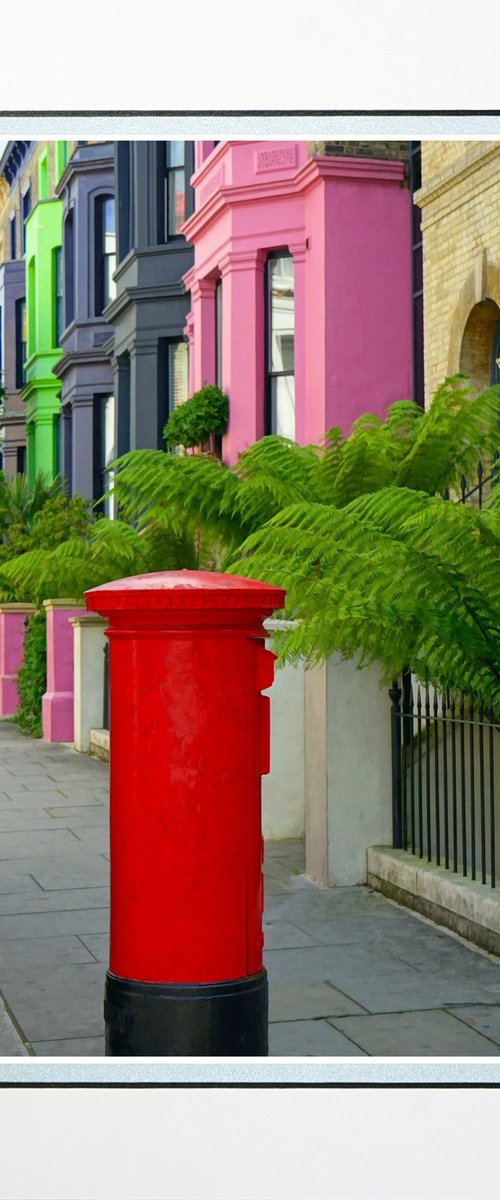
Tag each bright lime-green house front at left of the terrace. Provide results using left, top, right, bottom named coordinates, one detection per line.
left=22, top=200, right=62, bottom=484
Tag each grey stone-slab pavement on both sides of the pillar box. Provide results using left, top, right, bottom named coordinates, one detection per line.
left=0, top=720, right=500, bottom=1058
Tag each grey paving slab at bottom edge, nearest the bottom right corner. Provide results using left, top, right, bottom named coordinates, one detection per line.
left=331, top=1012, right=499, bottom=1058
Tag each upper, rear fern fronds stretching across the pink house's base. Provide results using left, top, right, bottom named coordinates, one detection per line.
left=114, top=376, right=500, bottom=551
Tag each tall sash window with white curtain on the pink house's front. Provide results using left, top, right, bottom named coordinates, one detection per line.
left=266, top=252, right=295, bottom=439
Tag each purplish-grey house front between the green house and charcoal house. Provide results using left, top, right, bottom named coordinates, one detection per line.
left=54, top=143, right=116, bottom=515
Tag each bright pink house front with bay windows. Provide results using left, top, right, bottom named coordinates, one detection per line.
left=182, top=142, right=411, bottom=463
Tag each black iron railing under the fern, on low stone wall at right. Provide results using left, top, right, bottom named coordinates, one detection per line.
left=390, top=678, right=500, bottom=888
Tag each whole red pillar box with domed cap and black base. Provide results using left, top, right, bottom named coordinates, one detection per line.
left=85, top=571, right=284, bottom=1056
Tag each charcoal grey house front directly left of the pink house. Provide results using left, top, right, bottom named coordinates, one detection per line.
left=106, top=142, right=194, bottom=454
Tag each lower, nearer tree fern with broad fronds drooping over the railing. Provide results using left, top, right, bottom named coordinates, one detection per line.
left=230, top=487, right=500, bottom=703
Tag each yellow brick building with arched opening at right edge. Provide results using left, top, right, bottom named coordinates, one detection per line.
left=415, top=142, right=500, bottom=404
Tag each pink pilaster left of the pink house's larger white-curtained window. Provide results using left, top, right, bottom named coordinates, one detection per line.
left=221, top=251, right=265, bottom=463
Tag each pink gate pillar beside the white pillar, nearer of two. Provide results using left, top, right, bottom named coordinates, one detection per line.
left=42, top=600, right=86, bottom=742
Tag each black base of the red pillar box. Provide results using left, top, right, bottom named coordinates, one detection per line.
left=104, top=970, right=269, bottom=1057
